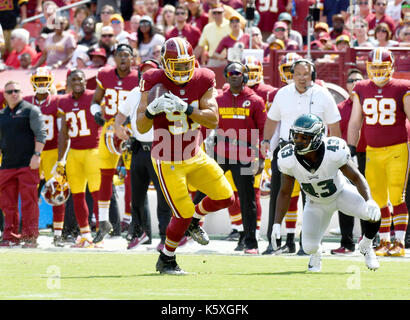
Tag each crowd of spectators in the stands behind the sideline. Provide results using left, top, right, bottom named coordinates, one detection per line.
left=0, top=0, right=410, bottom=69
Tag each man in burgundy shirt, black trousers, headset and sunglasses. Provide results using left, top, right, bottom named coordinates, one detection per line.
left=214, top=62, right=266, bottom=254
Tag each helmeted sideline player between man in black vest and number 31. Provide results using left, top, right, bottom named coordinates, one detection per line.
left=24, top=67, right=65, bottom=247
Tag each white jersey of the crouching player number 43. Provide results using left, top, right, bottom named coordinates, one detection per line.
left=278, top=137, right=350, bottom=203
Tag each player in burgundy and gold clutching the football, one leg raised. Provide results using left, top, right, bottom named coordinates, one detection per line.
left=137, top=38, right=233, bottom=274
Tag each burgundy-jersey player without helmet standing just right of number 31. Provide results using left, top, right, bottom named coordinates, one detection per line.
left=91, top=44, right=139, bottom=243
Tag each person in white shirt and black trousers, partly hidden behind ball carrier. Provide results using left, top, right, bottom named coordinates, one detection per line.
left=114, top=60, right=171, bottom=250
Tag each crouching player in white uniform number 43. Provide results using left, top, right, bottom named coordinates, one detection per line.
left=273, top=114, right=381, bottom=272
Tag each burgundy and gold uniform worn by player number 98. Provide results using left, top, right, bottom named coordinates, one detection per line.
left=353, top=77, right=410, bottom=255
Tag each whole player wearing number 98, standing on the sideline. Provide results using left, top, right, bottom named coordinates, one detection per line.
left=347, top=48, right=410, bottom=256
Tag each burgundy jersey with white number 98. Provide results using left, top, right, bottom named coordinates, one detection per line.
left=353, top=78, right=410, bottom=148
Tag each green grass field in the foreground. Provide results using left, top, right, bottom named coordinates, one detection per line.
left=0, top=250, right=410, bottom=300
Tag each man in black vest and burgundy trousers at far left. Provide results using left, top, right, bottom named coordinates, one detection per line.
left=0, top=81, right=47, bottom=248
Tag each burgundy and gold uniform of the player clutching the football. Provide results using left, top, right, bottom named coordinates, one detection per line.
left=140, top=66, right=233, bottom=252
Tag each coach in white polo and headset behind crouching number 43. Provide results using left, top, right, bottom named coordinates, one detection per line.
left=261, top=59, right=342, bottom=254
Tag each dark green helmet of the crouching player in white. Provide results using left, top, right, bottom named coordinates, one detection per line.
left=289, top=113, right=325, bottom=155
